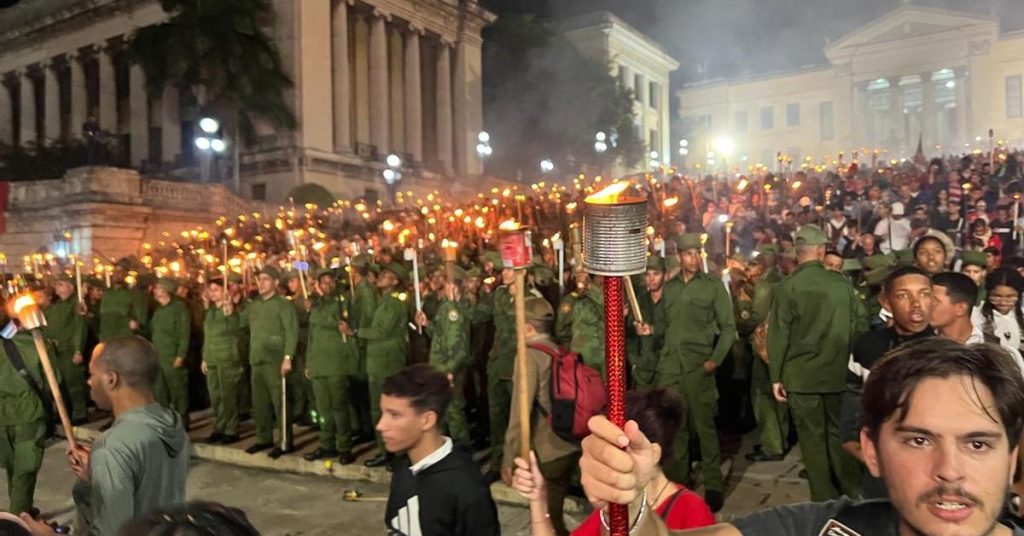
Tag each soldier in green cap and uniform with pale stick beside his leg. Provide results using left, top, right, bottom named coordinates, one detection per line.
left=242, top=265, right=299, bottom=458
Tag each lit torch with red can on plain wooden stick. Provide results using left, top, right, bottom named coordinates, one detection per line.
left=498, top=219, right=534, bottom=460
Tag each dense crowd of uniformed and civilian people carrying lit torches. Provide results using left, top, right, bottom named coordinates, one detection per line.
left=0, top=147, right=1024, bottom=536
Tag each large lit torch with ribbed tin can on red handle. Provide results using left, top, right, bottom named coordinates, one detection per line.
left=583, top=181, right=647, bottom=536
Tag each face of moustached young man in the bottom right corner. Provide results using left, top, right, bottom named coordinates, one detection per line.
left=860, top=375, right=1017, bottom=536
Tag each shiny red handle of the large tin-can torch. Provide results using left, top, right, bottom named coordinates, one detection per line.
left=604, top=277, right=630, bottom=536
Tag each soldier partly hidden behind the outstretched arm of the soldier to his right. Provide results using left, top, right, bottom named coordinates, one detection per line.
left=348, top=255, right=380, bottom=441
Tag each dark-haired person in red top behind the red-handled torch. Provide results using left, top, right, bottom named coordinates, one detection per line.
left=512, top=387, right=715, bottom=536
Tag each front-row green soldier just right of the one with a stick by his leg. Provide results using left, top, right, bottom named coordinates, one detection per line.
left=303, top=270, right=359, bottom=465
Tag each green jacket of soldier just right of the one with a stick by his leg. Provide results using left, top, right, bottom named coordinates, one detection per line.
left=306, top=293, right=359, bottom=378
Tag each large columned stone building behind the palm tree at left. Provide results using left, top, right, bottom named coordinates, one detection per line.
left=0, top=0, right=495, bottom=202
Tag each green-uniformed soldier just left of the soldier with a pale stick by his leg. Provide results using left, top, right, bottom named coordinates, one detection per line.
left=201, top=279, right=245, bottom=445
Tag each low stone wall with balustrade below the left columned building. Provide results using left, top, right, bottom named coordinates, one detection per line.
left=0, top=167, right=253, bottom=261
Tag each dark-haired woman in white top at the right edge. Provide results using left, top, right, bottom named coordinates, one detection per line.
left=975, top=267, right=1024, bottom=351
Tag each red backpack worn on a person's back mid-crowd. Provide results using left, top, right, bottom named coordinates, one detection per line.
left=527, top=343, right=608, bottom=443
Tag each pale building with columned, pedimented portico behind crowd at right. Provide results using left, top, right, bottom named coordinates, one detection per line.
left=677, top=4, right=1024, bottom=168
